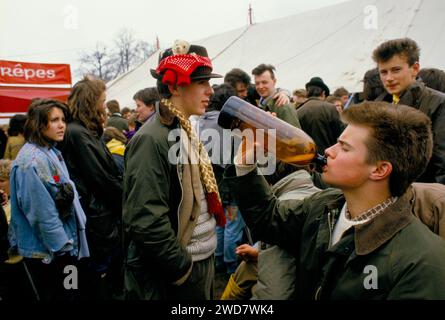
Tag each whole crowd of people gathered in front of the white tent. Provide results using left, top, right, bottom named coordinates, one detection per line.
left=0, top=38, right=445, bottom=301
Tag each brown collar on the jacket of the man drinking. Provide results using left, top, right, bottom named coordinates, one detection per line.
left=355, top=192, right=414, bottom=255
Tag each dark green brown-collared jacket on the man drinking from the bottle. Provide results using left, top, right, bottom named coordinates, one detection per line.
left=231, top=167, right=445, bottom=300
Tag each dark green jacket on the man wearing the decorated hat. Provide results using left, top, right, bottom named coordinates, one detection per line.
left=123, top=104, right=196, bottom=300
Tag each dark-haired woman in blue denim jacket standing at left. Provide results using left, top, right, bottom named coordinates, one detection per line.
left=10, top=100, right=89, bottom=300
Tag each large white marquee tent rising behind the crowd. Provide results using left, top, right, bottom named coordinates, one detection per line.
left=107, top=0, right=445, bottom=106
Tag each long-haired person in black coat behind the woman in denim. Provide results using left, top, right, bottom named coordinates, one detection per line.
left=60, top=77, right=122, bottom=299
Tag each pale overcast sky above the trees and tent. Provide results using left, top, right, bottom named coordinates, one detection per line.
left=0, top=0, right=345, bottom=80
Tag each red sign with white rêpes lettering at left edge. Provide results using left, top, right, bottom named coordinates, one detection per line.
left=0, top=60, right=71, bottom=85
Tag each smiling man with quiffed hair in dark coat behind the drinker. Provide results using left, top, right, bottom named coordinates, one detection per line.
left=373, top=38, right=445, bottom=184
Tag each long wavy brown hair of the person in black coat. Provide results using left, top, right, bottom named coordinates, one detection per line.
left=68, top=76, right=106, bottom=138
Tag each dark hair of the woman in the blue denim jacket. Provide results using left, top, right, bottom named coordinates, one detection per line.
left=24, top=99, right=69, bottom=147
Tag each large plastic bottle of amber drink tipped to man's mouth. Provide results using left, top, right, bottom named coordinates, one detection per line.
left=218, top=96, right=326, bottom=166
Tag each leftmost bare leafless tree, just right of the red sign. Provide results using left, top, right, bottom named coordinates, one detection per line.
left=79, top=42, right=118, bottom=82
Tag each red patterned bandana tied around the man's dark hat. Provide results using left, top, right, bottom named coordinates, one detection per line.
left=156, top=54, right=213, bottom=86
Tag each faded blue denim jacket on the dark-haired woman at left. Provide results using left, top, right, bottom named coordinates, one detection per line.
left=10, top=143, right=78, bottom=263
